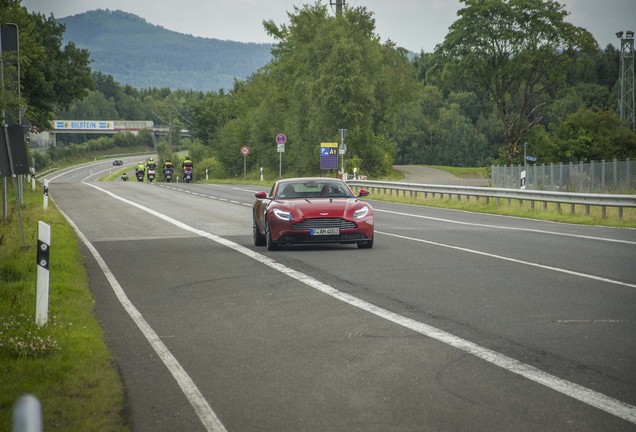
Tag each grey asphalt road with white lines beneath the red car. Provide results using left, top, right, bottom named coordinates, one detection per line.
left=42, top=162, right=636, bottom=432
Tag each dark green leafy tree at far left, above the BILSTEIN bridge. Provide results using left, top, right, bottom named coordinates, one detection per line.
left=0, top=0, right=94, bottom=129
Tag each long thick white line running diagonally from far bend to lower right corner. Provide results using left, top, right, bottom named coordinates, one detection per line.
left=80, top=183, right=636, bottom=424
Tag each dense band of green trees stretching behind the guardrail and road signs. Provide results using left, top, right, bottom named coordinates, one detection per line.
left=4, top=0, right=636, bottom=176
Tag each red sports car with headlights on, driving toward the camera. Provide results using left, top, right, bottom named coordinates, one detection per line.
left=252, top=177, right=374, bottom=251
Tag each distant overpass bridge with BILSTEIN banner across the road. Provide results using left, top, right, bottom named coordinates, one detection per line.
left=30, top=120, right=190, bottom=147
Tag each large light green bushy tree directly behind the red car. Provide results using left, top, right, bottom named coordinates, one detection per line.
left=209, top=4, right=419, bottom=176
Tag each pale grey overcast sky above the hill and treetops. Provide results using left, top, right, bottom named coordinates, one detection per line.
left=22, top=0, right=636, bottom=52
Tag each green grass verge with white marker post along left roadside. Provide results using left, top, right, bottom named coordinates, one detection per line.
left=0, top=179, right=128, bottom=431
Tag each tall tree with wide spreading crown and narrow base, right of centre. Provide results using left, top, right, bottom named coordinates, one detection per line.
left=436, top=0, right=597, bottom=163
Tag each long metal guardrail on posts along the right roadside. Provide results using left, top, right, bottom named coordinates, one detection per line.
left=347, top=180, right=636, bottom=219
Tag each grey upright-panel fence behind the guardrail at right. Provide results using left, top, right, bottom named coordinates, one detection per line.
left=491, top=159, right=636, bottom=194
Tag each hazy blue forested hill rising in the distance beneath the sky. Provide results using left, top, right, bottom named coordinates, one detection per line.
left=58, top=9, right=271, bottom=91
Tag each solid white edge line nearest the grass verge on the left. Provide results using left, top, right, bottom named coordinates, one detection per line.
left=58, top=197, right=227, bottom=432
